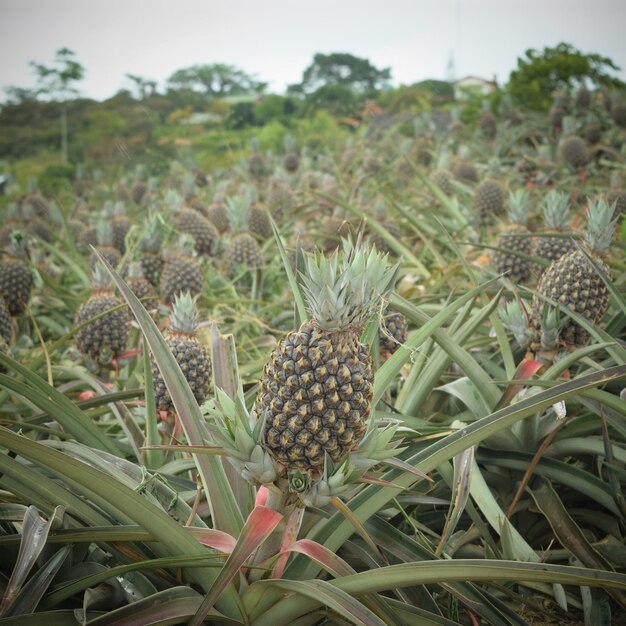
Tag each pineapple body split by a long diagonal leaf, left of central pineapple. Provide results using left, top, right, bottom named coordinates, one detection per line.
left=150, top=332, right=212, bottom=413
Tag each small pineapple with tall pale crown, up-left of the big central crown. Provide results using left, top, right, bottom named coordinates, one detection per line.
left=224, top=196, right=265, bottom=278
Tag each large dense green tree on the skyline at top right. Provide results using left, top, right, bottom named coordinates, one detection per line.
left=507, top=43, right=624, bottom=110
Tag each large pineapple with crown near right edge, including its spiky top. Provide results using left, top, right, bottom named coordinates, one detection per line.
left=531, top=200, right=617, bottom=348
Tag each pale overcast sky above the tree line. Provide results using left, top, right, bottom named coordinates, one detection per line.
left=0, top=0, right=626, bottom=100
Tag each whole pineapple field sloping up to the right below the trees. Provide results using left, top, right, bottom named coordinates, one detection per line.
left=0, top=74, right=626, bottom=626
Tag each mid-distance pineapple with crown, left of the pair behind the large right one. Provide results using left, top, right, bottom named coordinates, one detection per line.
left=491, top=189, right=533, bottom=283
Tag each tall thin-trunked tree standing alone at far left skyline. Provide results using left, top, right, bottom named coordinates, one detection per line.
left=30, top=48, right=85, bottom=163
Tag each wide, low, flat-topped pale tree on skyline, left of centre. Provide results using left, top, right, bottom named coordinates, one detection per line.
left=167, top=63, right=267, bottom=98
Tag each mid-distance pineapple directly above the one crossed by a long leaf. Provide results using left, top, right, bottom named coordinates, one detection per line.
left=161, top=235, right=204, bottom=304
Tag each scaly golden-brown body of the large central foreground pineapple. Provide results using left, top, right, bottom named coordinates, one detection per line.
left=256, top=321, right=373, bottom=474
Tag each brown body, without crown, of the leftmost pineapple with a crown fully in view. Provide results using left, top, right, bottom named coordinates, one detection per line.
left=74, top=295, right=130, bottom=363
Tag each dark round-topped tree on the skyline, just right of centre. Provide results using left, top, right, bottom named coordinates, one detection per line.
left=288, top=52, right=391, bottom=94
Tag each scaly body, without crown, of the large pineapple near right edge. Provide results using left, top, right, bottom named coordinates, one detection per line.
left=531, top=249, right=609, bottom=347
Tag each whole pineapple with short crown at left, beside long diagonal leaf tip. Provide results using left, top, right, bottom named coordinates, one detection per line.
left=74, top=264, right=130, bottom=365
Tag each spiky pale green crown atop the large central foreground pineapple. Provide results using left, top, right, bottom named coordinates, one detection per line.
left=301, top=240, right=399, bottom=331
